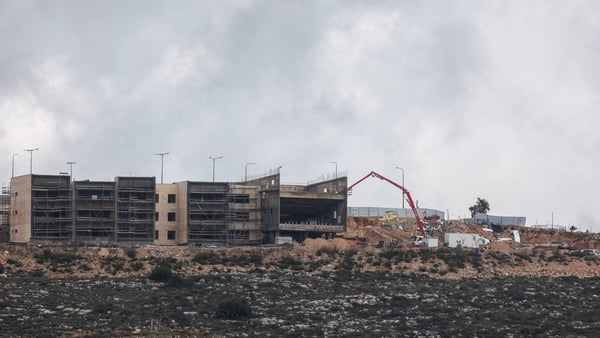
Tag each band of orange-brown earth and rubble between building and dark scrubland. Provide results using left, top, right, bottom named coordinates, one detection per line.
left=0, top=218, right=600, bottom=279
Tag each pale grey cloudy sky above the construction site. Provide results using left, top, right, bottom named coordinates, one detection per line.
left=0, top=0, right=600, bottom=231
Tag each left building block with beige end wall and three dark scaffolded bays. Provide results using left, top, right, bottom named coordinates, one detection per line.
left=10, top=175, right=156, bottom=243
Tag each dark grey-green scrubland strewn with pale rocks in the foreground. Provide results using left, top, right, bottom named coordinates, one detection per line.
left=0, top=270, right=600, bottom=337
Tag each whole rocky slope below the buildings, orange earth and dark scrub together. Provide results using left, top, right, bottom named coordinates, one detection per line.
left=0, top=220, right=600, bottom=337
